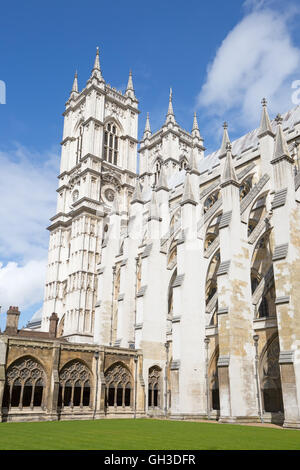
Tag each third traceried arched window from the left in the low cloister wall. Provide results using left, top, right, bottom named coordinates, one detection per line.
left=105, top=363, right=132, bottom=408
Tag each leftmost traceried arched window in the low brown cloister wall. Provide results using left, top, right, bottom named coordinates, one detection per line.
left=3, top=358, right=46, bottom=409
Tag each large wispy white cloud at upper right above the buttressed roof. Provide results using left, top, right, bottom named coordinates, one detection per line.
left=198, top=0, right=300, bottom=128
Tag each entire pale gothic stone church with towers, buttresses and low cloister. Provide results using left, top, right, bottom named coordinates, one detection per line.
left=0, top=51, right=300, bottom=428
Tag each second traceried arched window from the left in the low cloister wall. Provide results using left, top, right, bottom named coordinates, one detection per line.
left=58, top=360, right=91, bottom=408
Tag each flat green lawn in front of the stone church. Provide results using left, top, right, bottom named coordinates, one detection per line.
left=0, top=419, right=300, bottom=450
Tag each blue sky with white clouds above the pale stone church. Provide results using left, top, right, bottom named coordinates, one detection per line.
left=0, top=0, right=300, bottom=328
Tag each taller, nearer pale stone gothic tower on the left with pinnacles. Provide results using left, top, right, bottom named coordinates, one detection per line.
left=42, top=48, right=139, bottom=342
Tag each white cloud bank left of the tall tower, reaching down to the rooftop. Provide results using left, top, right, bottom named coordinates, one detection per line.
left=0, top=145, right=59, bottom=326
